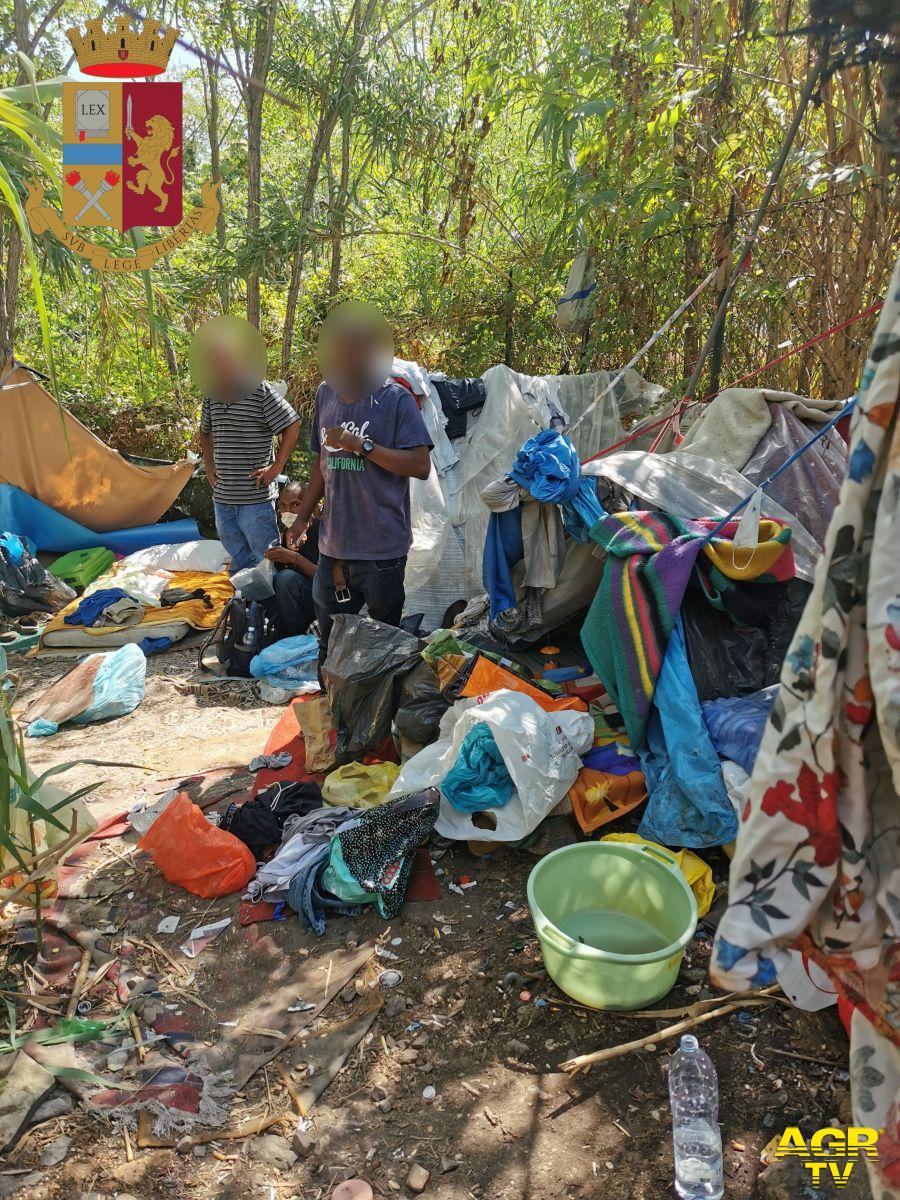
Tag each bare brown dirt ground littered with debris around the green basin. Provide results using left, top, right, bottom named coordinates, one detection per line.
left=0, top=652, right=850, bottom=1200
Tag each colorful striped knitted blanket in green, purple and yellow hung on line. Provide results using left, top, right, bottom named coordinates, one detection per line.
left=581, top=512, right=794, bottom=749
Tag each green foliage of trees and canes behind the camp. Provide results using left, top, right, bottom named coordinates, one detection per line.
left=0, top=0, right=900, bottom=456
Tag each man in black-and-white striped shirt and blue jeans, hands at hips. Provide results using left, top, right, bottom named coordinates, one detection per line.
left=200, top=343, right=300, bottom=575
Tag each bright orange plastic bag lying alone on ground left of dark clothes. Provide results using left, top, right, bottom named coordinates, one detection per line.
left=138, top=792, right=257, bottom=900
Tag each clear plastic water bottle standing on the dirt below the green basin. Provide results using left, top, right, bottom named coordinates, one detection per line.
left=668, top=1033, right=725, bottom=1200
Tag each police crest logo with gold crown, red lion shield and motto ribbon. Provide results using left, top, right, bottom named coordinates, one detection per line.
left=25, top=17, right=218, bottom=271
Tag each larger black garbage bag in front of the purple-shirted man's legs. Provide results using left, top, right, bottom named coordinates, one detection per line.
left=322, top=613, right=422, bottom=762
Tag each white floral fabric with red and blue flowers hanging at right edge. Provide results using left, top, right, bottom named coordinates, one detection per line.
left=712, top=263, right=900, bottom=1200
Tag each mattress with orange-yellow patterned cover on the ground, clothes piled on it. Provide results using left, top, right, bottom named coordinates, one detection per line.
left=41, top=564, right=234, bottom=650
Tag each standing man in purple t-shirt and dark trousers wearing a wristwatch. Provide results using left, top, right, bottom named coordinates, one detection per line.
left=295, top=312, right=432, bottom=650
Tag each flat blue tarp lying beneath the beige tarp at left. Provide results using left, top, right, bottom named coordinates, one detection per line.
left=0, top=484, right=200, bottom=554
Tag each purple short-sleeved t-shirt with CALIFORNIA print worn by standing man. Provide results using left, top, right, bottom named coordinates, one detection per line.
left=310, top=380, right=432, bottom=559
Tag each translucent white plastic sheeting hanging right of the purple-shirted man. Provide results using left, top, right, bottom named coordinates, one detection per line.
left=406, top=366, right=662, bottom=628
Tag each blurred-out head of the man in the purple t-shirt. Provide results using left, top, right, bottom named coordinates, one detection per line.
left=319, top=301, right=394, bottom=400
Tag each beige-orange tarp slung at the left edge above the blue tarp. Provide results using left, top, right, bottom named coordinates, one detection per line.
left=0, top=364, right=193, bottom=533
